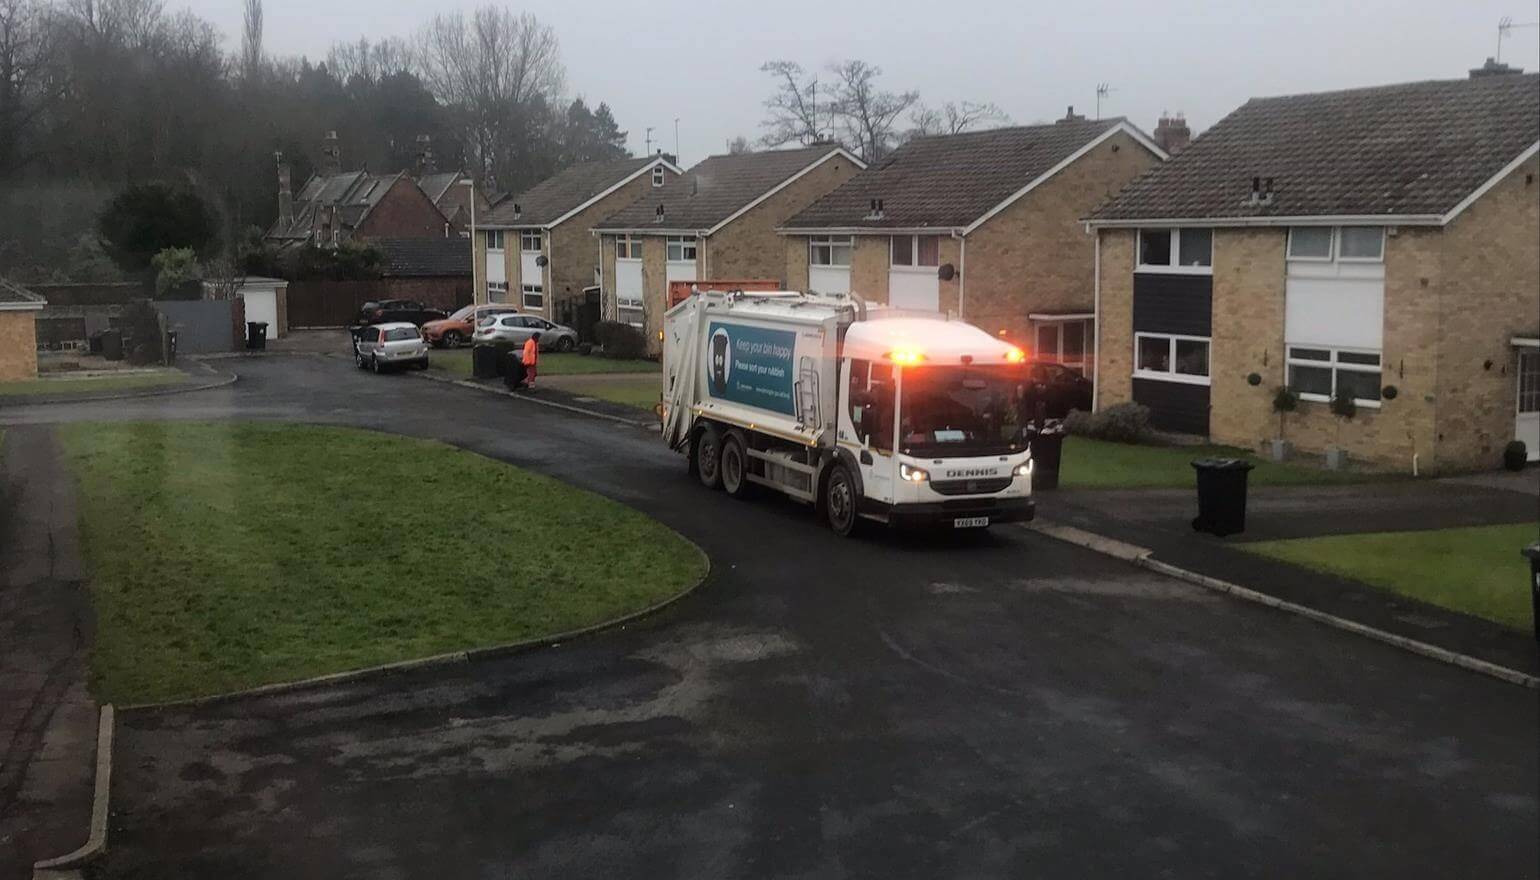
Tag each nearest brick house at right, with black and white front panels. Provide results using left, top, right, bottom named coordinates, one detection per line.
left=1089, top=72, right=1540, bottom=472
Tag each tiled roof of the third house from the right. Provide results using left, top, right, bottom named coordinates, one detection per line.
left=596, top=143, right=839, bottom=230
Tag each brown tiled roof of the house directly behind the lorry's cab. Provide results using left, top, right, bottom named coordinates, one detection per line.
left=785, top=119, right=1123, bottom=230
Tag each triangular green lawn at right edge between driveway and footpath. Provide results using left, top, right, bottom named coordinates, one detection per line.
left=1237, top=522, right=1537, bottom=629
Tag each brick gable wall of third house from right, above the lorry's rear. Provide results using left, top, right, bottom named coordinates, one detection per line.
left=701, top=156, right=859, bottom=282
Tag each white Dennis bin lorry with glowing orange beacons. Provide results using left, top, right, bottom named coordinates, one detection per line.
left=662, top=291, right=1033, bottom=535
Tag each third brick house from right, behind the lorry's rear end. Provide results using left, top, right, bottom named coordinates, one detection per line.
left=594, top=143, right=865, bottom=342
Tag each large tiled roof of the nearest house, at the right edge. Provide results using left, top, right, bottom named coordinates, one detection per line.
left=1092, top=74, right=1540, bottom=220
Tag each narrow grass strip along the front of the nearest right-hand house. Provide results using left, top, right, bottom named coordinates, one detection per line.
left=1060, top=436, right=1386, bottom=489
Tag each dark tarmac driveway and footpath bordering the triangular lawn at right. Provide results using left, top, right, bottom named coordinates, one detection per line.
left=1046, top=469, right=1540, bottom=675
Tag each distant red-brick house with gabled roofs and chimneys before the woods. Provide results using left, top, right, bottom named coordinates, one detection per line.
left=263, top=131, right=451, bottom=248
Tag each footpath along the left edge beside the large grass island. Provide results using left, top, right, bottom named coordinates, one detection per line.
left=0, top=427, right=97, bottom=877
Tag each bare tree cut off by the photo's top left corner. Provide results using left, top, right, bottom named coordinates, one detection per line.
left=0, top=0, right=62, bottom=179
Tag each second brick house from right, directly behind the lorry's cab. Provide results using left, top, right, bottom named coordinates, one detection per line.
left=779, top=111, right=1166, bottom=370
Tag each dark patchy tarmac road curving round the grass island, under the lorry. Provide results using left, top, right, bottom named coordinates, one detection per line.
left=0, top=358, right=1540, bottom=878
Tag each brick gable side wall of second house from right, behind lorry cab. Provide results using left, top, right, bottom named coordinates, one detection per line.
left=942, top=133, right=1160, bottom=338
